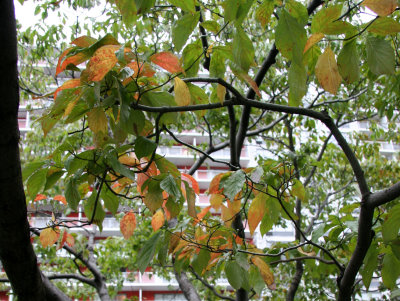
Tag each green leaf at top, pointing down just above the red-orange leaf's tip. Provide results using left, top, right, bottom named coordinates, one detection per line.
left=172, top=12, right=200, bottom=52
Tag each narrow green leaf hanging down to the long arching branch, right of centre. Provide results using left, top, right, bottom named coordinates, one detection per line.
left=288, top=61, right=307, bottom=107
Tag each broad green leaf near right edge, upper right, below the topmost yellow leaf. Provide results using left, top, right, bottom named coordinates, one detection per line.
left=366, top=36, right=396, bottom=76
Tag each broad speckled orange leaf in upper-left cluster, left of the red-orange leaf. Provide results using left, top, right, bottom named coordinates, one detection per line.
left=87, top=45, right=120, bottom=82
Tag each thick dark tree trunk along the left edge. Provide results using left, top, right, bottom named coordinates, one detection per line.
left=0, top=0, right=69, bottom=301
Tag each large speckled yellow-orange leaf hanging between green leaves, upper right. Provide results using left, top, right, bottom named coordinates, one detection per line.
left=315, top=47, right=342, bottom=94
